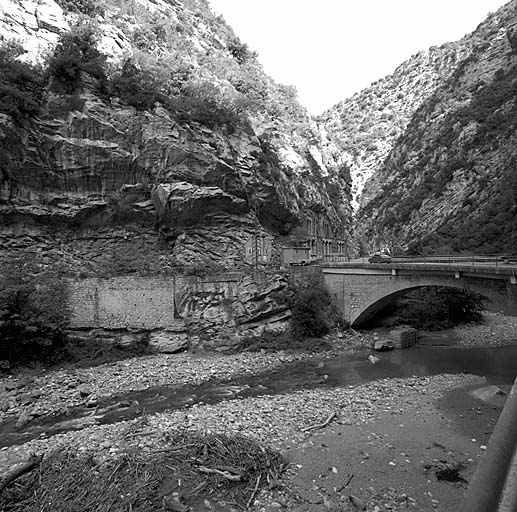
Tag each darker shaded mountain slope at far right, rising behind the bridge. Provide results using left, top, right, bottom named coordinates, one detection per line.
left=358, top=0, right=517, bottom=252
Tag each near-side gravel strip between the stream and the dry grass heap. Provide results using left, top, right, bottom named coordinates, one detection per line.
left=0, top=375, right=472, bottom=471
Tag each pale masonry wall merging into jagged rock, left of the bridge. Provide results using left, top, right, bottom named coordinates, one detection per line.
left=68, top=272, right=290, bottom=336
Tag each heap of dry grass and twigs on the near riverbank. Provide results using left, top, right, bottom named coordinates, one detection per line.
left=0, top=431, right=286, bottom=512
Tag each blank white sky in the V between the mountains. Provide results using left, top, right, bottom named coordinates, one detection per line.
left=210, top=0, right=507, bottom=114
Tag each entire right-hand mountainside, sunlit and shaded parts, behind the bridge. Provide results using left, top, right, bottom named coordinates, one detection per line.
left=320, top=1, right=517, bottom=253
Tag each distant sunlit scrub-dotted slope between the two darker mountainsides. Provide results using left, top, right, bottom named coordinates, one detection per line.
left=318, top=38, right=469, bottom=208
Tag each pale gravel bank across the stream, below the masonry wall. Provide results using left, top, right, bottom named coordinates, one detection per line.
left=0, top=332, right=373, bottom=423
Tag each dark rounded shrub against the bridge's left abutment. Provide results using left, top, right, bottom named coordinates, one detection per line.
left=290, top=276, right=338, bottom=338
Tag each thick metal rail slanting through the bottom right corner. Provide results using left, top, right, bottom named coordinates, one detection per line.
left=459, top=379, right=517, bottom=512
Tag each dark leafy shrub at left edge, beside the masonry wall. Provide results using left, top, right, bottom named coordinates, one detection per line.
left=0, top=257, right=68, bottom=362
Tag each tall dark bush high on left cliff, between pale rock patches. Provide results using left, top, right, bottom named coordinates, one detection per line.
left=47, top=25, right=106, bottom=94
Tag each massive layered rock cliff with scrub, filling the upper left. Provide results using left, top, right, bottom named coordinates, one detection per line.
left=0, top=0, right=350, bottom=273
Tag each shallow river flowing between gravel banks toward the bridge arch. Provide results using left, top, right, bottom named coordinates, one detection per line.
left=0, top=346, right=517, bottom=447
